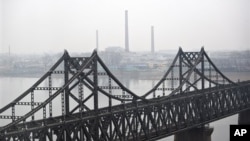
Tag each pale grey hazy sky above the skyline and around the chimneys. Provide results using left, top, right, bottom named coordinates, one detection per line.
left=0, top=0, right=250, bottom=53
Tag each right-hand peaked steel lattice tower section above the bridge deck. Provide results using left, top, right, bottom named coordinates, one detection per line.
left=143, top=48, right=234, bottom=98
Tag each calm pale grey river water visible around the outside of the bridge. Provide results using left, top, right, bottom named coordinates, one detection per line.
left=0, top=72, right=250, bottom=141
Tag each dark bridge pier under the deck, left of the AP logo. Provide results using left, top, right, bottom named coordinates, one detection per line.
left=174, top=126, right=214, bottom=141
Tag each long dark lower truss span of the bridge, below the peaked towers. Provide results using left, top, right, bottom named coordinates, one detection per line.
left=1, top=81, right=250, bottom=141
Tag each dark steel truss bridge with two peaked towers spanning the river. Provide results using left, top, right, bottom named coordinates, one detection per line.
left=0, top=48, right=250, bottom=141
